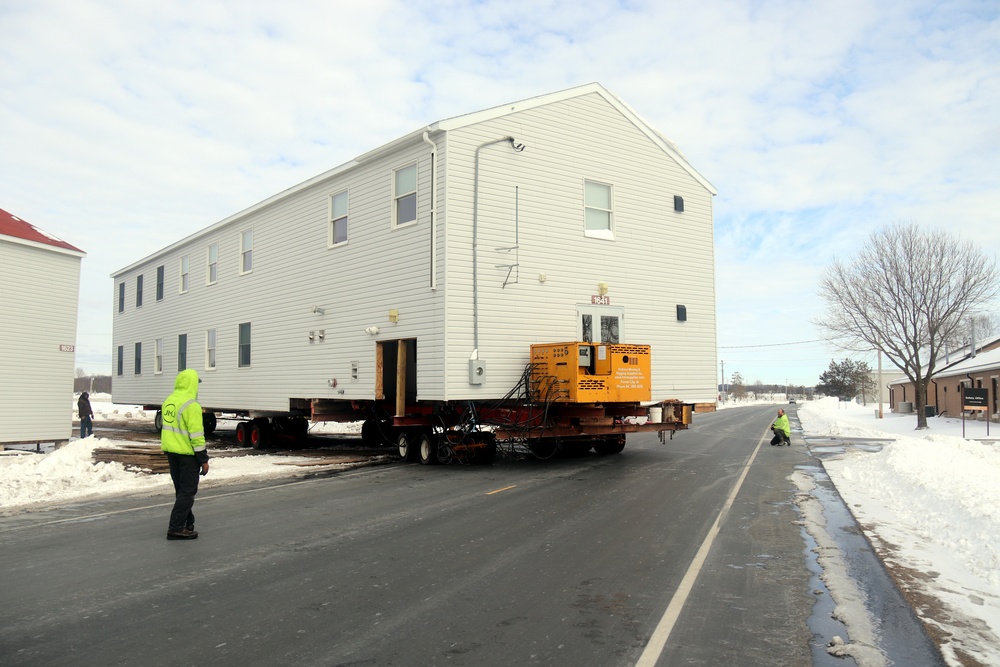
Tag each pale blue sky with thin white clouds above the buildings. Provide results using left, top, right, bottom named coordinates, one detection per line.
left=0, top=0, right=1000, bottom=385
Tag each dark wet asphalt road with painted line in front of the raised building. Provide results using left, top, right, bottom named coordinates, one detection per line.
left=0, top=409, right=936, bottom=667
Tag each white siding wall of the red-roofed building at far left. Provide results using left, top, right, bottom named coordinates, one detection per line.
left=0, top=241, right=80, bottom=443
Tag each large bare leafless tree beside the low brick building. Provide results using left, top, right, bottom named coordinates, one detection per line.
left=816, top=223, right=1000, bottom=429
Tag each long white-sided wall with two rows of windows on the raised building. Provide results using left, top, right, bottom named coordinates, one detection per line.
left=113, top=143, right=450, bottom=411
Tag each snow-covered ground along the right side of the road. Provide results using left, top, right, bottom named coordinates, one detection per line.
left=798, top=398, right=1000, bottom=665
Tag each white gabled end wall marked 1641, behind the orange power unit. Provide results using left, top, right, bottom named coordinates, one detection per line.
left=447, top=94, right=716, bottom=401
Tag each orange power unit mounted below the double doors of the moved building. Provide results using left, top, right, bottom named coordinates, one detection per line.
left=531, top=342, right=652, bottom=403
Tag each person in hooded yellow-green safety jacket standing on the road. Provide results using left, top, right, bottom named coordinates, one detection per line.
left=160, top=368, right=208, bottom=540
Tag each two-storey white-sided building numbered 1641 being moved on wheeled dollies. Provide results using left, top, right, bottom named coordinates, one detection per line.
left=112, top=84, right=717, bottom=454
